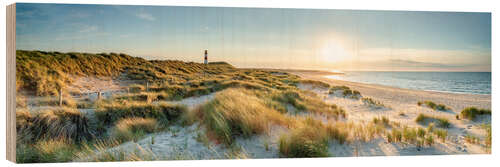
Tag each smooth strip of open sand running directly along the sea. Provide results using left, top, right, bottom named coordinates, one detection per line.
left=280, top=70, right=491, bottom=112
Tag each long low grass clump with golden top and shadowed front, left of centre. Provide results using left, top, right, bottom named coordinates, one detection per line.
left=95, top=101, right=187, bottom=125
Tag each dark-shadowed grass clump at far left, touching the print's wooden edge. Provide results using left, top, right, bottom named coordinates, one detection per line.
left=16, top=108, right=95, bottom=142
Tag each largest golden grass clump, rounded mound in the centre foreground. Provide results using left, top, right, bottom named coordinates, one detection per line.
left=192, top=88, right=287, bottom=144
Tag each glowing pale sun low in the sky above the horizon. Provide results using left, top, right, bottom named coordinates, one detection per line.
left=319, top=39, right=351, bottom=62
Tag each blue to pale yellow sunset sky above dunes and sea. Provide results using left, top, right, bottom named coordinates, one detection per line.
left=16, top=3, right=491, bottom=71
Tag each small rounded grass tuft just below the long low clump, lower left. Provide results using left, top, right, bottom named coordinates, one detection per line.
left=112, top=117, right=158, bottom=142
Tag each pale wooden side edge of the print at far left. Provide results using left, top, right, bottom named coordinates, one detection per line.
left=6, top=4, right=16, bottom=162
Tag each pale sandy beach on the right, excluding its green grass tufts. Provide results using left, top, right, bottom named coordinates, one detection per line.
left=283, top=70, right=491, bottom=155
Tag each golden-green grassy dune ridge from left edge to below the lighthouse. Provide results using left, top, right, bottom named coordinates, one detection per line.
left=16, top=50, right=235, bottom=96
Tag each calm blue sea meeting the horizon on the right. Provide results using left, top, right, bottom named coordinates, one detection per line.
left=327, top=71, right=491, bottom=95
